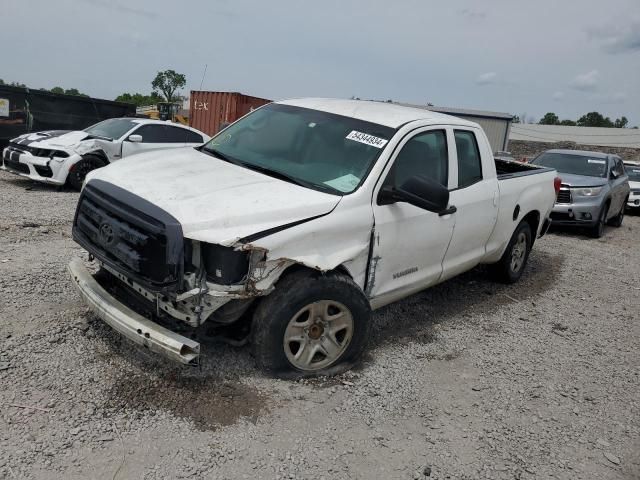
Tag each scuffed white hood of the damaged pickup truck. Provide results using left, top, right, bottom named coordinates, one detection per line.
left=87, top=148, right=342, bottom=245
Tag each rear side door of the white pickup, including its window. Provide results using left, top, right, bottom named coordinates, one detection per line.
left=442, top=127, right=499, bottom=280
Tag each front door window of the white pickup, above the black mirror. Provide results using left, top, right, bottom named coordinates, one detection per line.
left=387, top=130, right=449, bottom=187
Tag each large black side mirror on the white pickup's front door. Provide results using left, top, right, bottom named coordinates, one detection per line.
left=378, top=175, right=456, bottom=215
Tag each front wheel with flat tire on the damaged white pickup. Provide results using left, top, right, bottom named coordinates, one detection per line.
left=251, top=271, right=371, bottom=378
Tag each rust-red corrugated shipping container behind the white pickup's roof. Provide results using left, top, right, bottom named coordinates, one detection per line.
left=189, top=90, right=271, bottom=135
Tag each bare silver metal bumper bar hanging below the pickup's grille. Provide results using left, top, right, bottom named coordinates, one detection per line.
left=68, top=258, right=200, bottom=365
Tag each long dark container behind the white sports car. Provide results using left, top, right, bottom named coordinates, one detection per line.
left=0, top=85, right=136, bottom=150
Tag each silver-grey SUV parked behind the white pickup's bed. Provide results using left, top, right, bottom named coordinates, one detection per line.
left=531, top=150, right=630, bottom=238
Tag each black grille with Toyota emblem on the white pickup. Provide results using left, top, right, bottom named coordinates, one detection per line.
left=73, top=180, right=188, bottom=292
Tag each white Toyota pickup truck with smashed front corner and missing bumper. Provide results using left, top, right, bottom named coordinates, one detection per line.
left=69, top=99, right=559, bottom=376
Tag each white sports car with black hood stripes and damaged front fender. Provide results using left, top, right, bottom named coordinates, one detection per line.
left=1, top=118, right=209, bottom=190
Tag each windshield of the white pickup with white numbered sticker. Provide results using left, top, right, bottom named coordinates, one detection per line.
left=202, top=103, right=394, bottom=195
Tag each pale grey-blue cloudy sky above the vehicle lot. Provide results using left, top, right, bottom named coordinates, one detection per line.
left=5, top=0, right=640, bottom=125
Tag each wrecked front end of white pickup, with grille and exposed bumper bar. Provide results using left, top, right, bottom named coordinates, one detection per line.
left=69, top=181, right=292, bottom=364
